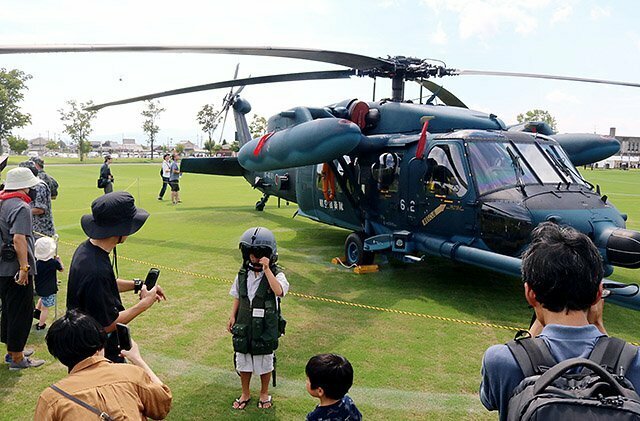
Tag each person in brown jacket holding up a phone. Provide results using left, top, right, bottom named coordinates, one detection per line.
left=34, top=310, right=172, bottom=421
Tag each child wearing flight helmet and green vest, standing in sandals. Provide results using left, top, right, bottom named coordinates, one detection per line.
left=227, top=227, right=289, bottom=409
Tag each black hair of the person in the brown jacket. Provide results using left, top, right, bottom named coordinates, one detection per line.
left=45, top=310, right=107, bottom=371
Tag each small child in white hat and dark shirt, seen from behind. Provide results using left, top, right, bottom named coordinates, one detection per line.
left=33, top=237, right=63, bottom=330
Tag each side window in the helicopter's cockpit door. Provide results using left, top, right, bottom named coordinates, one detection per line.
left=424, top=145, right=469, bottom=197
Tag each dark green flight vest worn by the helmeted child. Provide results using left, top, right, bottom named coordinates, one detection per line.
left=231, top=266, right=286, bottom=355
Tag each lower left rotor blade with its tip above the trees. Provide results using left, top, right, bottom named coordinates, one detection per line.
left=87, top=70, right=355, bottom=110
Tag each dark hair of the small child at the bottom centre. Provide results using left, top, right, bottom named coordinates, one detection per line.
left=304, top=354, right=353, bottom=399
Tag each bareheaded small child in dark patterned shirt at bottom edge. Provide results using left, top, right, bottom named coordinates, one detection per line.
left=305, top=354, right=362, bottom=421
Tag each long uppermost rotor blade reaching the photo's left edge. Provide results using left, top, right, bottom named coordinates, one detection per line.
left=0, top=44, right=394, bottom=70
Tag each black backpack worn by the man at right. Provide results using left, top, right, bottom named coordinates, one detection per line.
left=507, top=336, right=640, bottom=421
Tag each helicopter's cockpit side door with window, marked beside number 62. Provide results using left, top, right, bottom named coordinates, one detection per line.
left=400, top=140, right=475, bottom=238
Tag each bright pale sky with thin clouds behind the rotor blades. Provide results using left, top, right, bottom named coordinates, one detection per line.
left=0, top=0, right=640, bottom=144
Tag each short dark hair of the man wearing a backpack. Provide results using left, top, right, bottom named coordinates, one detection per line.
left=522, top=222, right=603, bottom=313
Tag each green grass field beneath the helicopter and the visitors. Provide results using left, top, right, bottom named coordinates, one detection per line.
left=0, top=164, right=640, bottom=420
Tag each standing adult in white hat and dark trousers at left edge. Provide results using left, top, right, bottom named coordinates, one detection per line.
left=0, top=168, right=44, bottom=370
